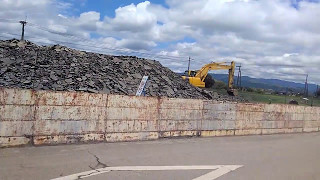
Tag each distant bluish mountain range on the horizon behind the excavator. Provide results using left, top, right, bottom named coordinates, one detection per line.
left=211, top=74, right=317, bottom=93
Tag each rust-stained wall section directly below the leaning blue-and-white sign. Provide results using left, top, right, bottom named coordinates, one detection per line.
left=105, top=95, right=159, bottom=136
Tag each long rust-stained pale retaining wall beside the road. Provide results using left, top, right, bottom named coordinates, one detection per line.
left=0, top=88, right=320, bottom=147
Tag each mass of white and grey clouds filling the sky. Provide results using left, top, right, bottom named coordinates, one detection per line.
left=0, top=0, right=320, bottom=82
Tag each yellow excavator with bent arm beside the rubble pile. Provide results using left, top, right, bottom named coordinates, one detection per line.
left=182, top=61, right=238, bottom=96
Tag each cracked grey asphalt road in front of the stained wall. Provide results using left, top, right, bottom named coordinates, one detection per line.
left=0, top=133, right=320, bottom=180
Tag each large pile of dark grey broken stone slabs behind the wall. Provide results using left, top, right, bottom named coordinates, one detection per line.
left=0, top=39, right=245, bottom=101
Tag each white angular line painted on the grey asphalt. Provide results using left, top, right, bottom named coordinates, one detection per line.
left=52, top=165, right=242, bottom=180
